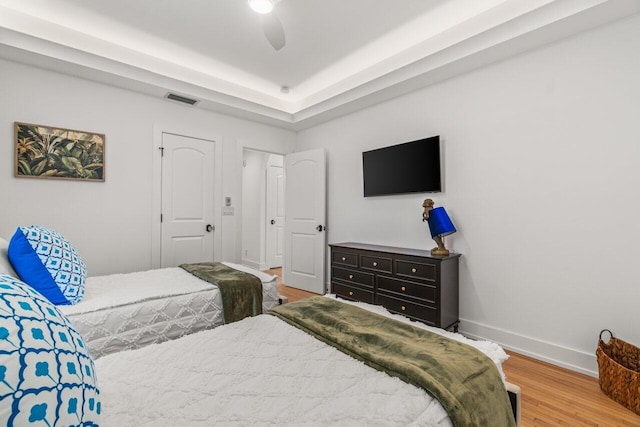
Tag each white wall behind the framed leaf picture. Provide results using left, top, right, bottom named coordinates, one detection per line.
left=0, top=60, right=295, bottom=275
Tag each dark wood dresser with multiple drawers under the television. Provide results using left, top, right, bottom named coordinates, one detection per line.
left=329, top=243, right=460, bottom=330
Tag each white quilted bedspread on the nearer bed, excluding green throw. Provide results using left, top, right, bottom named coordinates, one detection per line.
left=96, top=300, right=506, bottom=427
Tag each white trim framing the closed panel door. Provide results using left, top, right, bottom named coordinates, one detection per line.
left=151, top=123, right=223, bottom=268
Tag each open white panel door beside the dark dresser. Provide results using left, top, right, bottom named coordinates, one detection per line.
left=283, top=148, right=326, bottom=294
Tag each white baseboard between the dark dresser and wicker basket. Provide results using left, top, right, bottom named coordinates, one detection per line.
left=459, top=319, right=598, bottom=377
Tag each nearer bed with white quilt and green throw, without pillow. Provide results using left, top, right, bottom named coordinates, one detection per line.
left=96, top=296, right=516, bottom=427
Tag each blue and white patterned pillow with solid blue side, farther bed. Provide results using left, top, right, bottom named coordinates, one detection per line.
left=9, top=225, right=87, bottom=305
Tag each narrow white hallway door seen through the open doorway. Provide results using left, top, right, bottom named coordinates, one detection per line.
left=266, top=165, right=285, bottom=268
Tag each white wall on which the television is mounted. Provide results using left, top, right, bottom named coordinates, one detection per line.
left=296, top=16, right=640, bottom=374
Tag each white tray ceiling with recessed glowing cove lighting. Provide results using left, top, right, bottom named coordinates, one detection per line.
left=0, top=0, right=640, bottom=130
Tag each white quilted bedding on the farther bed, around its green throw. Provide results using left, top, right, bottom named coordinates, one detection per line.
left=59, top=267, right=278, bottom=358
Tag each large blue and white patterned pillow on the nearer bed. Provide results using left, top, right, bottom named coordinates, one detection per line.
left=0, top=274, right=101, bottom=427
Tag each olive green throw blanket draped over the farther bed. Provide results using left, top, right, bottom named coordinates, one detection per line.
left=180, top=262, right=262, bottom=323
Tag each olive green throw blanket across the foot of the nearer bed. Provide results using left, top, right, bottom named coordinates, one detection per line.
left=269, top=297, right=515, bottom=427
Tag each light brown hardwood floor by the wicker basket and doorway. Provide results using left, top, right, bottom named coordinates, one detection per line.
left=269, top=269, right=640, bottom=427
